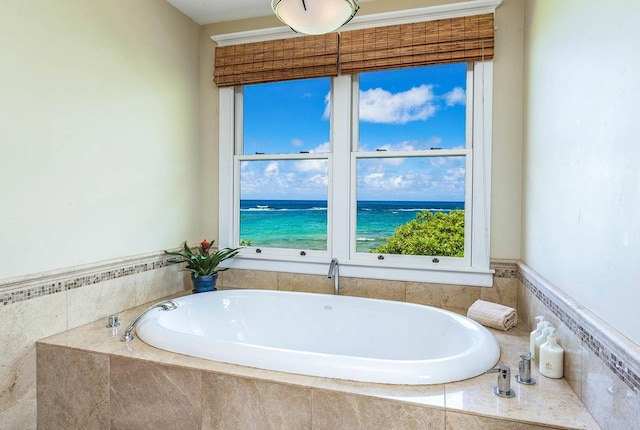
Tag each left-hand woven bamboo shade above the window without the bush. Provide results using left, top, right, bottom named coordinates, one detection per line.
left=213, top=33, right=338, bottom=87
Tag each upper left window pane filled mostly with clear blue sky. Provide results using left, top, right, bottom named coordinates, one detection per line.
left=242, top=78, right=331, bottom=155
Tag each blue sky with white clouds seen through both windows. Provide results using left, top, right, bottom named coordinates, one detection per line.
left=241, top=64, right=466, bottom=201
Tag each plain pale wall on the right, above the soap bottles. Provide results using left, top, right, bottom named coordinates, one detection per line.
left=522, top=0, right=640, bottom=344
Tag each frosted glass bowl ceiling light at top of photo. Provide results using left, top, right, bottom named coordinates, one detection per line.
left=271, top=0, right=359, bottom=34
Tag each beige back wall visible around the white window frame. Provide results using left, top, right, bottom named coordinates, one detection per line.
left=201, top=0, right=524, bottom=259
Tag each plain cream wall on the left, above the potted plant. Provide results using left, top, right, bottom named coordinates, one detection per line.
left=0, top=0, right=200, bottom=279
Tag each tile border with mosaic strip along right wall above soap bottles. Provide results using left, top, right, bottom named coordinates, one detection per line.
left=517, top=262, right=640, bottom=394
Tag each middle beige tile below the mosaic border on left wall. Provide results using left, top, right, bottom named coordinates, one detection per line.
left=67, top=275, right=136, bottom=328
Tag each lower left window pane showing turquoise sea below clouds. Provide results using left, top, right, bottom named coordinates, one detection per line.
left=240, top=159, right=328, bottom=250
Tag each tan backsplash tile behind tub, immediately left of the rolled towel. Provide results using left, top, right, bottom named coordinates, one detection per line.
left=407, top=282, right=481, bottom=309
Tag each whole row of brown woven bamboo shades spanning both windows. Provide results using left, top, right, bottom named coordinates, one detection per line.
left=214, top=13, right=494, bottom=87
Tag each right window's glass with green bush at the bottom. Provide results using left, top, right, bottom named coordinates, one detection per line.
left=351, top=63, right=472, bottom=264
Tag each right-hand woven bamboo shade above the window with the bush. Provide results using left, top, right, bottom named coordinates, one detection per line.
left=340, top=13, right=494, bottom=74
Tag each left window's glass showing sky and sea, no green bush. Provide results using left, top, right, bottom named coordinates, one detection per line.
left=239, top=78, right=331, bottom=254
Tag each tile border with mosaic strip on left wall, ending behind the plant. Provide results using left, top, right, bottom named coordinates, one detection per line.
left=0, top=253, right=171, bottom=306
